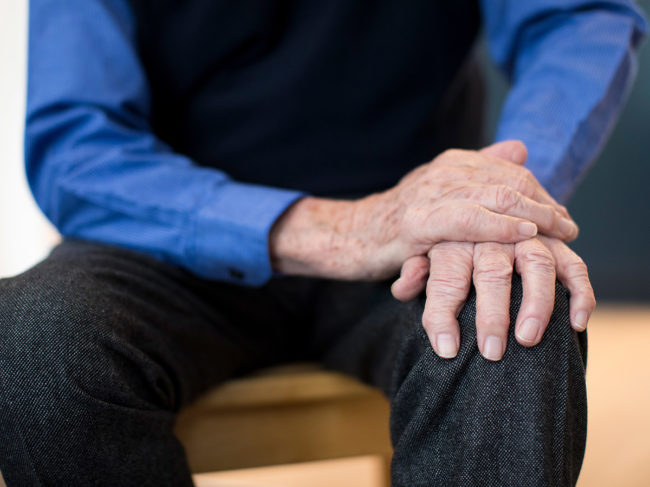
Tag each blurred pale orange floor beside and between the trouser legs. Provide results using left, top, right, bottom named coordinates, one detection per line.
left=196, top=306, right=650, bottom=487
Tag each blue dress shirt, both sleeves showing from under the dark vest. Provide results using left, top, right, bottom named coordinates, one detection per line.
left=25, top=0, right=646, bottom=285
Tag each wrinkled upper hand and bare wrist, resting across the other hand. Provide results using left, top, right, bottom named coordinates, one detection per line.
left=269, top=142, right=578, bottom=280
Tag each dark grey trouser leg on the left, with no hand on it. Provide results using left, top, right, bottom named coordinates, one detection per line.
left=0, top=242, right=302, bottom=487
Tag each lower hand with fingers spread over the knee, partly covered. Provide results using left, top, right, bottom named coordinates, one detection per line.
left=392, top=236, right=596, bottom=360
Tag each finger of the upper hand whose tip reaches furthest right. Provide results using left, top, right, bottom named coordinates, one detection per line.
left=447, top=184, right=578, bottom=241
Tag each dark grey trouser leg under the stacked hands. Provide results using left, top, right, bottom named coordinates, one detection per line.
left=313, top=276, right=587, bottom=487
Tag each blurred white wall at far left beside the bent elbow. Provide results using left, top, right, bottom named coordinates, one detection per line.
left=0, top=0, right=58, bottom=277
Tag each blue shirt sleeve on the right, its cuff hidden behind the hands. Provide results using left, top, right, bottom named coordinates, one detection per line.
left=481, top=0, right=647, bottom=201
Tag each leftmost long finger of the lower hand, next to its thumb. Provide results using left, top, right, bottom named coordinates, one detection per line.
left=422, top=242, right=474, bottom=358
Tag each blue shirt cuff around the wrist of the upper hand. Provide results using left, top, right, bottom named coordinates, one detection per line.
left=186, top=181, right=305, bottom=286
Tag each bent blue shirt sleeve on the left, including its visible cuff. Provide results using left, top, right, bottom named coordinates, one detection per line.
left=25, top=0, right=302, bottom=286
